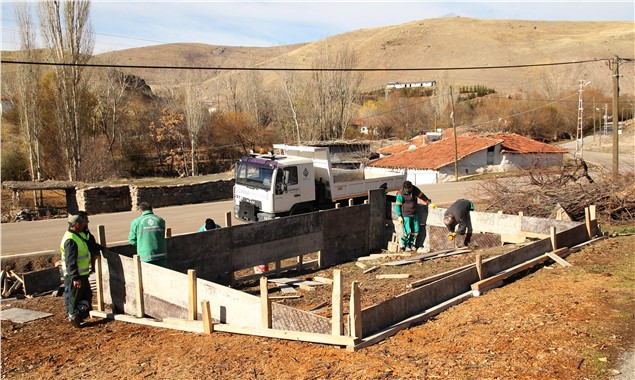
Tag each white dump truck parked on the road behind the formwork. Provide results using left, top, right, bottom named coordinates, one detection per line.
left=234, top=144, right=406, bottom=222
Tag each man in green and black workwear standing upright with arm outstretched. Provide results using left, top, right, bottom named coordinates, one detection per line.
left=395, top=181, right=434, bottom=252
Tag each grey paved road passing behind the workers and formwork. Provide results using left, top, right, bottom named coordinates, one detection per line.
left=0, top=181, right=477, bottom=257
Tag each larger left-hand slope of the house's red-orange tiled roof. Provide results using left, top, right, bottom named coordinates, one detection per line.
left=368, top=136, right=501, bottom=170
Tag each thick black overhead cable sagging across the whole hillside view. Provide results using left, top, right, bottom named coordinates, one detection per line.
left=1, top=58, right=610, bottom=72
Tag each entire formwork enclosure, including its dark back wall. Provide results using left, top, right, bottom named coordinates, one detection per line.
left=96, top=190, right=598, bottom=350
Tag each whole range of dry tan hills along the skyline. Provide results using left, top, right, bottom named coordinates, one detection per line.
left=88, top=17, right=635, bottom=98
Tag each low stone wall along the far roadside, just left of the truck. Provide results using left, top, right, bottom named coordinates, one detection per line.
left=77, top=180, right=234, bottom=215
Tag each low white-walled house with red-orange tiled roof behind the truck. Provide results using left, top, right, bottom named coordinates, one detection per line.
left=366, top=133, right=567, bottom=184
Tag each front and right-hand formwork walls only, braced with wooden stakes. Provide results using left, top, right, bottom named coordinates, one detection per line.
left=92, top=208, right=598, bottom=351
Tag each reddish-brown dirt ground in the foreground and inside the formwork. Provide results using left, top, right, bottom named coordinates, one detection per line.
left=0, top=230, right=635, bottom=379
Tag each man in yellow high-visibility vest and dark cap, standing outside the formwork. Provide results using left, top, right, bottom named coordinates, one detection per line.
left=60, top=215, right=96, bottom=328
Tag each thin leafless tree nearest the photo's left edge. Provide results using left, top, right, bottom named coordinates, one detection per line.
left=15, top=3, right=42, bottom=181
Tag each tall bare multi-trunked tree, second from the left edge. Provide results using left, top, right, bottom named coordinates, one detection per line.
left=38, top=0, right=94, bottom=181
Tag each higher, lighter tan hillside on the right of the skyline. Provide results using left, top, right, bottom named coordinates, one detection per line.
left=253, top=17, right=635, bottom=94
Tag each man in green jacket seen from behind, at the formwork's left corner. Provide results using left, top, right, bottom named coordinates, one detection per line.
left=128, top=202, right=168, bottom=268
